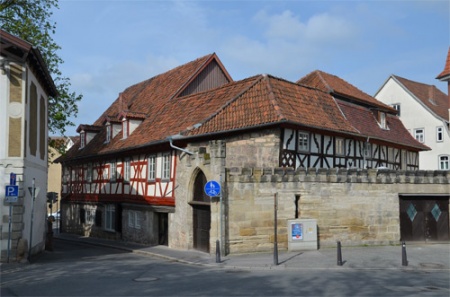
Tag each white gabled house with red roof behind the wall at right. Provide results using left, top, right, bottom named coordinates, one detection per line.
left=375, top=49, right=450, bottom=170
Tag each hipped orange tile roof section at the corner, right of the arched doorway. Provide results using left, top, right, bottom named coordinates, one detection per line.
left=184, top=75, right=357, bottom=135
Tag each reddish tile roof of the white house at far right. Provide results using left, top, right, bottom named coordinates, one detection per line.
left=392, top=75, right=450, bottom=121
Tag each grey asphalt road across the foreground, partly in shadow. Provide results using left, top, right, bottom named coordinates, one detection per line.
left=1, top=240, right=450, bottom=296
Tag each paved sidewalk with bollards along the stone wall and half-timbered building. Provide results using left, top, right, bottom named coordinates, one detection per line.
left=55, top=233, right=450, bottom=270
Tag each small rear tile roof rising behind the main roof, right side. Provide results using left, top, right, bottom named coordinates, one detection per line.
left=297, top=70, right=397, bottom=113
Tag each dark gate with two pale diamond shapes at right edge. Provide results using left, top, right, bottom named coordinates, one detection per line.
left=400, top=196, right=450, bottom=241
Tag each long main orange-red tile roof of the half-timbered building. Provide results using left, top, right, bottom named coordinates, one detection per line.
left=60, top=55, right=427, bottom=159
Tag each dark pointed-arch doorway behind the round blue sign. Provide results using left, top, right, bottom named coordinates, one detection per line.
left=190, top=171, right=211, bottom=253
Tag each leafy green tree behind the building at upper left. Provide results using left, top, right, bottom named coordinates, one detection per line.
left=0, top=0, right=82, bottom=135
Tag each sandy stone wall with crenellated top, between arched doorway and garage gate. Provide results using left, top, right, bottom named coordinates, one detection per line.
left=227, top=168, right=450, bottom=253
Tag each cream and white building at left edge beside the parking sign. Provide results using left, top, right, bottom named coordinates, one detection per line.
left=0, top=30, right=57, bottom=262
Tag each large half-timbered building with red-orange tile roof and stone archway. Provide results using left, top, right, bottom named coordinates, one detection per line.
left=59, top=54, right=442, bottom=252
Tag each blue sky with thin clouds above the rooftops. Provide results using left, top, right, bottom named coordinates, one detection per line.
left=52, top=0, right=450, bottom=135
